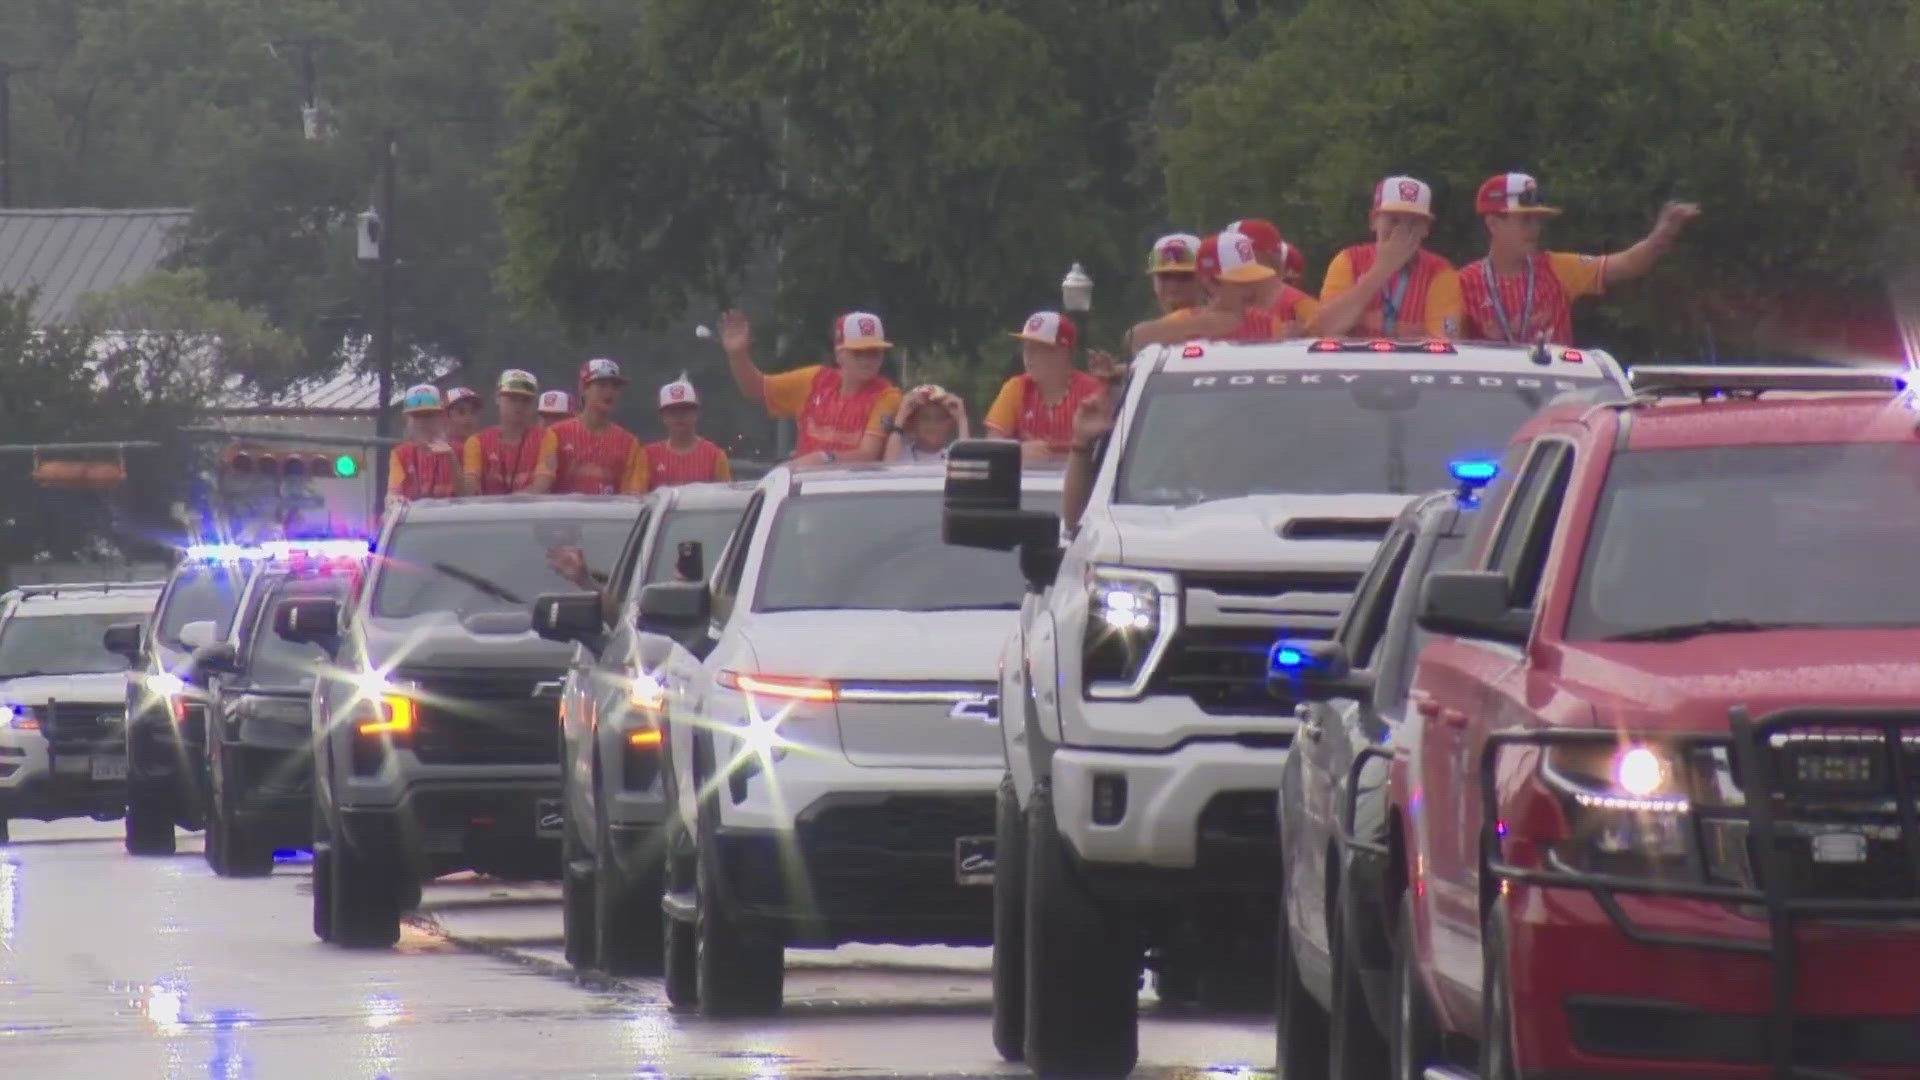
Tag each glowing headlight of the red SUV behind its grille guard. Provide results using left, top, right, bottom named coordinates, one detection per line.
left=1532, top=742, right=1693, bottom=876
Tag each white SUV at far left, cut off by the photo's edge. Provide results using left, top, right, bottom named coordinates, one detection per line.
left=0, top=582, right=161, bottom=842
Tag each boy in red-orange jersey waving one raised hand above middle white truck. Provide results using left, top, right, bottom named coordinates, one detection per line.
left=720, top=311, right=900, bottom=465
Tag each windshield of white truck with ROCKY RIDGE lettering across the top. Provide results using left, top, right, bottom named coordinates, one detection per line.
left=1114, top=357, right=1605, bottom=505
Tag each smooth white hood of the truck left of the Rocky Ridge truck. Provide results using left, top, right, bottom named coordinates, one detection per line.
left=747, top=609, right=1020, bottom=682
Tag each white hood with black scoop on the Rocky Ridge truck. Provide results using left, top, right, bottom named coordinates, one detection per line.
left=1092, top=494, right=1413, bottom=571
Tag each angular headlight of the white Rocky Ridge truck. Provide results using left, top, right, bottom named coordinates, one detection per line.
left=1081, top=567, right=1179, bottom=698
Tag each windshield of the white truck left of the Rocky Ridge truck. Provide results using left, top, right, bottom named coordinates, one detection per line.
left=753, top=492, right=1060, bottom=611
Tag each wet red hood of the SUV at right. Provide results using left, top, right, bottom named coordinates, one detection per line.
left=1559, top=628, right=1920, bottom=732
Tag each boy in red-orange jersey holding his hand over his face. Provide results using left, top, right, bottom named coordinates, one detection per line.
left=1308, top=177, right=1459, bottom=338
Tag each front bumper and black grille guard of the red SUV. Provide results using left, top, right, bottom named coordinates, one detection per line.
left=1478, top=707, right=1920, bottom=1080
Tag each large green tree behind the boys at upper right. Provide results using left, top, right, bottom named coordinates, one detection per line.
left=1154, top=0, right=1920, bottom=356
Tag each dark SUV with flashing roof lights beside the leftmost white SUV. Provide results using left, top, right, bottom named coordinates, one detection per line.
left=102, top=544, right=259, bottom=855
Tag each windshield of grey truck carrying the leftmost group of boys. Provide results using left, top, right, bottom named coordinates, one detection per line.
left=372, top=518, right=639, bottom=619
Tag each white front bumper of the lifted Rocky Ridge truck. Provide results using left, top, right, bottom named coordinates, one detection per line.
left=1052, top=742, right=1286, bottom=892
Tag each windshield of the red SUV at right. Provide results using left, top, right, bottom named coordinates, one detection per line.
left=1567, top=444, right=1920, bottom=640
